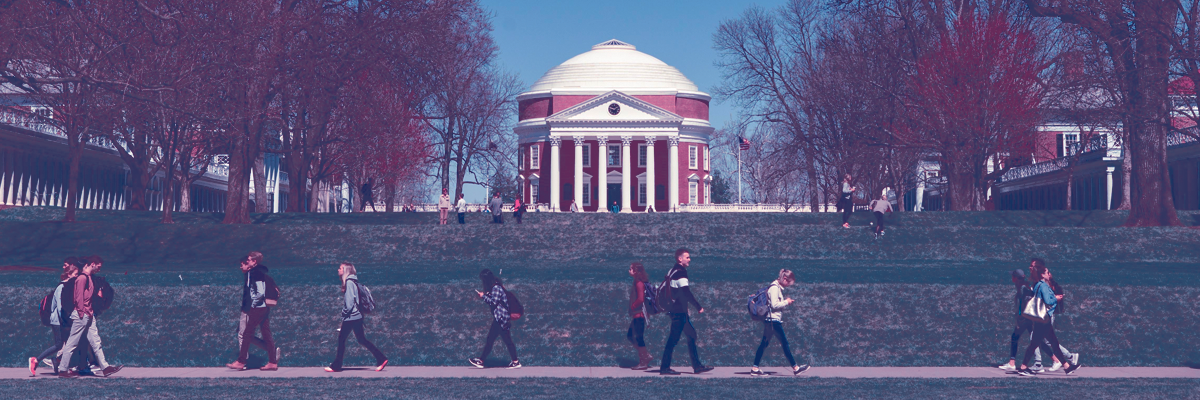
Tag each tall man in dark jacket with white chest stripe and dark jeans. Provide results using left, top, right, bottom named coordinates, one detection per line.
left=659, top=249, right=713, bottom=375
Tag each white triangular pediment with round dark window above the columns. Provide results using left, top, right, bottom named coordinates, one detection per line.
left=546, top=90, right=683, bottom=124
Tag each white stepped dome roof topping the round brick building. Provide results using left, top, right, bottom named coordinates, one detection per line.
left=529, top=38, right=698, bottom=91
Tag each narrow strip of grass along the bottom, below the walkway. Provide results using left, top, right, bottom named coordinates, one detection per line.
left=0, top=377, right=1200, bottom=399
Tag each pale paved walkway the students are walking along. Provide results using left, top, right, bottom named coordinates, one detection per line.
left=0, top=365, right=1200, bottom=380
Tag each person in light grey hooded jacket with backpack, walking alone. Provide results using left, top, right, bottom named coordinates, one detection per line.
left=325, top=263, right=388, bottom=372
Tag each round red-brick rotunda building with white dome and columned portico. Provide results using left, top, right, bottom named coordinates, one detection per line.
left=514, top=40, right=713, bottom=213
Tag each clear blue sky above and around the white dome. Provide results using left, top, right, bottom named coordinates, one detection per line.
left=451, top=0, right=786, bottom=202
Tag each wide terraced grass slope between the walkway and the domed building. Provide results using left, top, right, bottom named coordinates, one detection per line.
left=0, top=208, right=1200, bottom=367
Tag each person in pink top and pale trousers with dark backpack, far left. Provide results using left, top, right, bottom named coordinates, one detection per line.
left=58, top=256, right=121, bottom=378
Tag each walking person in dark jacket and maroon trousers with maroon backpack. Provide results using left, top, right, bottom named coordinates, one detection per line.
left=226, top=251, right=281, bottom=371
